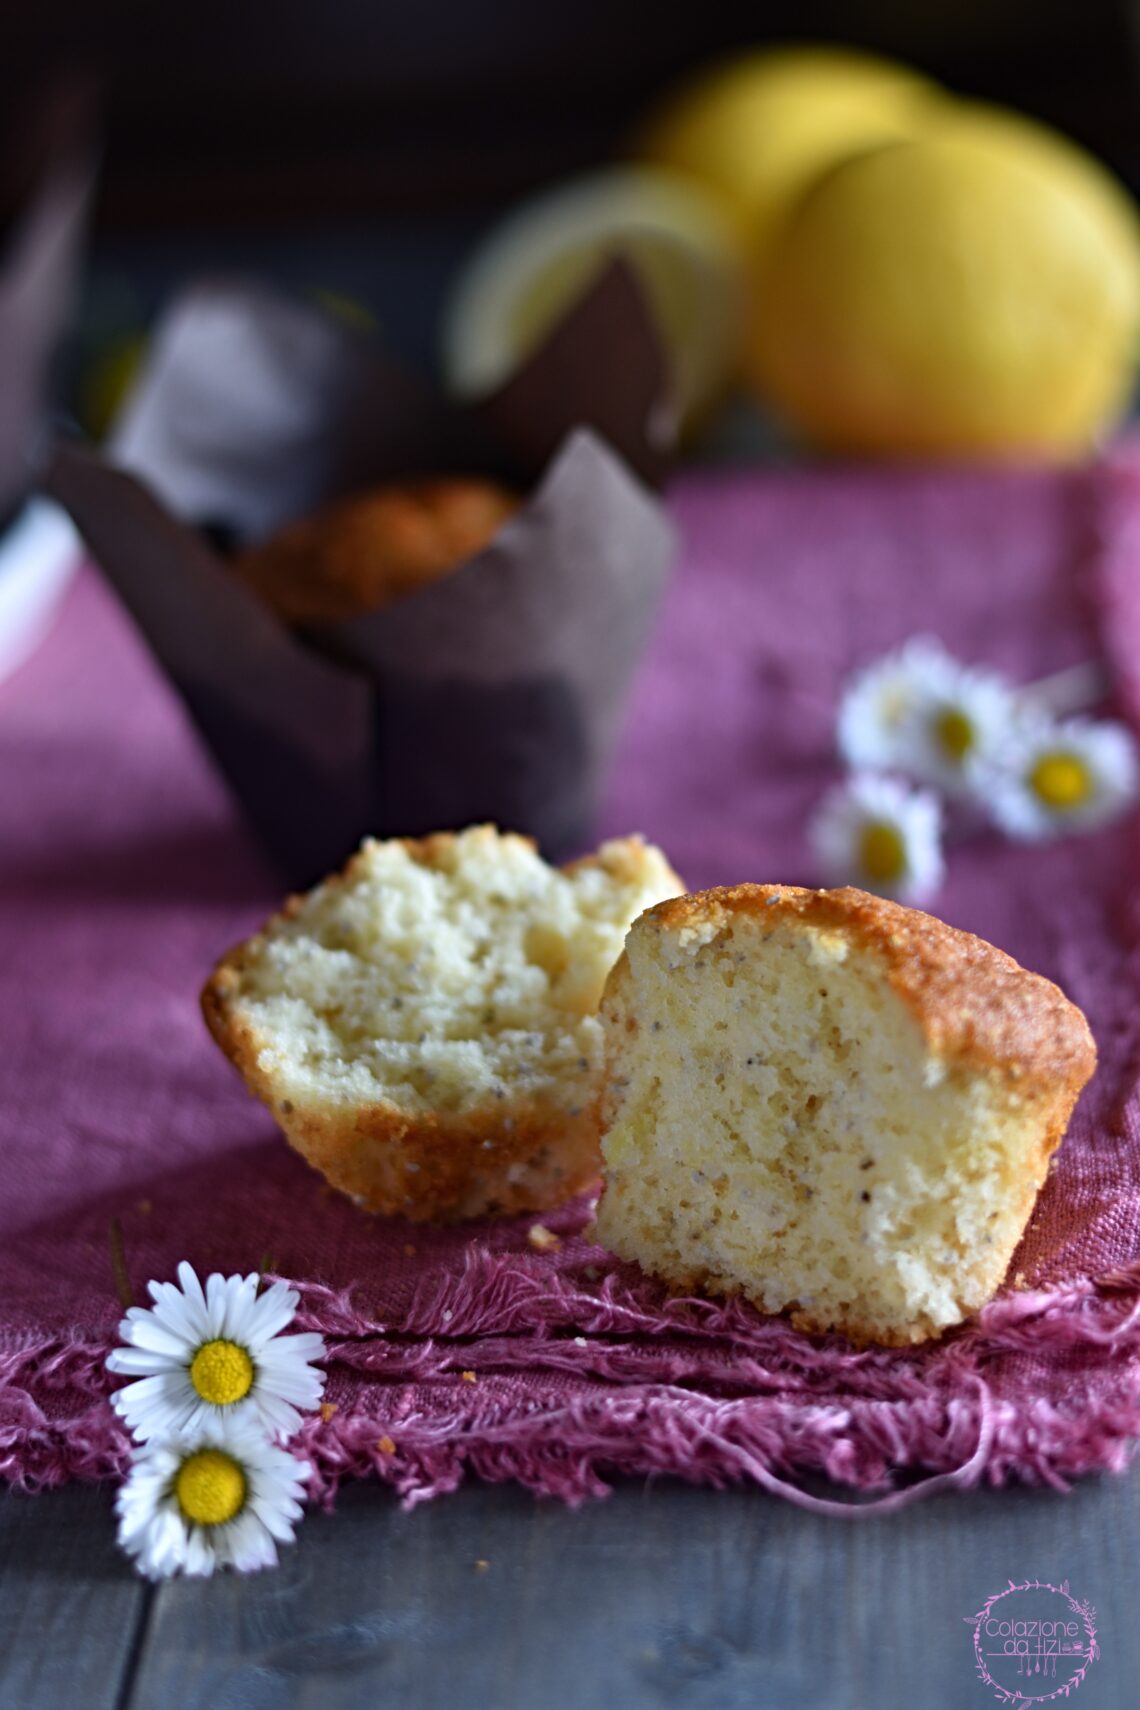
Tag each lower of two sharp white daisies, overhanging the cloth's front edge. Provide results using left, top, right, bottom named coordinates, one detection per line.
left=115, top=1419, right=311, bottom=1580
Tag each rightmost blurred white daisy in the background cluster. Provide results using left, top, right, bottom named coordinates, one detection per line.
left=984, top=718, right=1138, bottom=841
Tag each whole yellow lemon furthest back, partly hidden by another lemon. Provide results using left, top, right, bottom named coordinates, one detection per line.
left=638, top=48, right=940, bottom=258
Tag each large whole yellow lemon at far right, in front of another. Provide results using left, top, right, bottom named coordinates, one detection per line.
left=747, top=103, right=1140, bottom=457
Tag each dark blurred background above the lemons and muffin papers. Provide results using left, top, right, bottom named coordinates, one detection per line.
left=0, top=0, right=1140, bottom=388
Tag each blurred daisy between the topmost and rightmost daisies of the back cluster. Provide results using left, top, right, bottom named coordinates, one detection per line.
left=897, top=653, right=1019, bottom=797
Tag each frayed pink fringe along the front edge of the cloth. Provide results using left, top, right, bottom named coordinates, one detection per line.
left=0, top=1252, right=1140, bottom=1518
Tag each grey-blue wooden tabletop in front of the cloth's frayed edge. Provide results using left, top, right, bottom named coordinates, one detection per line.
left=0, top=1471, right=1140, bottom=1710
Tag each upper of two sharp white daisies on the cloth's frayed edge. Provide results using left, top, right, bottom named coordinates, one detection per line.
left=108, top=1262, right=325, bottom=1442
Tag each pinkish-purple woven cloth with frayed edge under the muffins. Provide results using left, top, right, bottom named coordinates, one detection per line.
left=0, top=453, right=1140, bottom=1512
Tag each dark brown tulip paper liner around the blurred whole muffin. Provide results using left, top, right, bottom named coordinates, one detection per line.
left=46, top=262, right=675, bottom=886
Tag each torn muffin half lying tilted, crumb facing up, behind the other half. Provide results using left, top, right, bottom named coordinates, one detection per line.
left=202, top=826, right=682, bottom=1219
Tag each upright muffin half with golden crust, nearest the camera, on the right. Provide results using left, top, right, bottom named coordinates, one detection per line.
left=596, top=884, right=1096, bottom=1344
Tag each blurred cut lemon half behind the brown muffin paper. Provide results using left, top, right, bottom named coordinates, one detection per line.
left=443, top=168, right=740, bottom=421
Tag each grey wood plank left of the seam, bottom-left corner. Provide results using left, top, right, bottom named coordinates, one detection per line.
left=0, top=1486, right=152, bottom=1710
